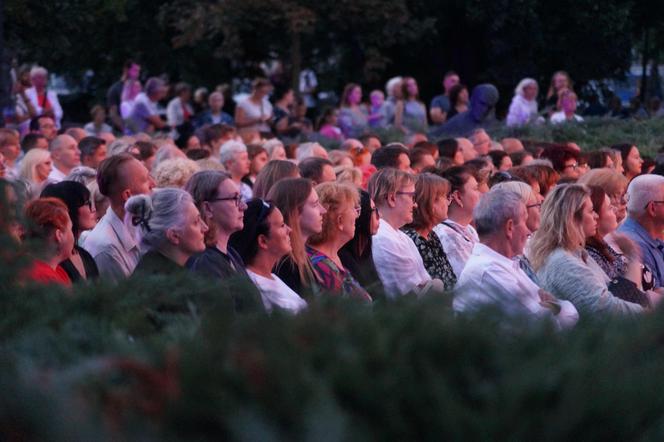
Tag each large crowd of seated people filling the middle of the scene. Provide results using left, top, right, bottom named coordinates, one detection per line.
left=6, top=60, right=664, bottom=328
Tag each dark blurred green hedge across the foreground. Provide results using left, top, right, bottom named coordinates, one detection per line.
left=0, top=260, right=664, bottom=441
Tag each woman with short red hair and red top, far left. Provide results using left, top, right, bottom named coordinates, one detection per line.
left=21, top=198, right=74, bottom=286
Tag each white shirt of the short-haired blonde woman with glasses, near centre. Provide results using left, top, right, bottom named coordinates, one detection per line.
left=371, top=219, right=431, bottom=298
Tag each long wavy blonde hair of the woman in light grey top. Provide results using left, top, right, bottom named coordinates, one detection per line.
left=528, top=184, right=590, bottom=270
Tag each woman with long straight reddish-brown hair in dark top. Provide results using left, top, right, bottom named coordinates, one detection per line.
left=267, top=178, right=325, bottom=298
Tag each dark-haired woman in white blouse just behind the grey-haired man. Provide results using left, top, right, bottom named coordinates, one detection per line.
left=433, top=166, right=481, bottom=276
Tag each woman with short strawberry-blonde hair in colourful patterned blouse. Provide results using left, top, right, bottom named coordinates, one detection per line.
left=307, top=183, right=371, bottom=301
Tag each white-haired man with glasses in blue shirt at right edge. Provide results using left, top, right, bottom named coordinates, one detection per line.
left=618, top=175, right=664, bottom=288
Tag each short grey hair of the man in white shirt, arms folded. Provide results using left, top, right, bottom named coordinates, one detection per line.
left=473, top=189, right=524, bottom=236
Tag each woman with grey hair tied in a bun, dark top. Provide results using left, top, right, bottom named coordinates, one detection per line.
left=125, top=188, right=208, bottom=275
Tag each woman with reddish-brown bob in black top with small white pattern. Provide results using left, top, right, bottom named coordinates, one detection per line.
left=402, top=173, right=457, bottom=291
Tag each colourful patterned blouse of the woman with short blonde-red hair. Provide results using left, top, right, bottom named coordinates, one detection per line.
left=307, top=246, right=372, bottom=302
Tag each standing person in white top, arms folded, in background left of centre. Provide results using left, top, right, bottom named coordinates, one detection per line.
left=235, top=78, right=274, bottom=136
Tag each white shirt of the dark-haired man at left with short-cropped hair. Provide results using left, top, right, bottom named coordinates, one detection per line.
left=83, top=207, right=141, bottom=281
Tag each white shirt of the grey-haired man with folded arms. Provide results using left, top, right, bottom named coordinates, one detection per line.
left=452, top=243, right=579, bottom=327
